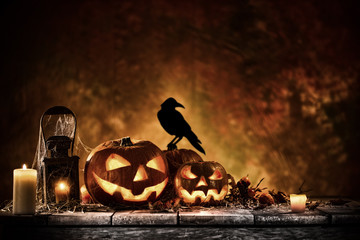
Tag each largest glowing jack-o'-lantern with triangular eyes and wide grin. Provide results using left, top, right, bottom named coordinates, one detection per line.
left=85, top=137, right=168, bottom=206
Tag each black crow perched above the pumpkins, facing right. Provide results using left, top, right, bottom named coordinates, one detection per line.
left=157, top=98, right=205, bottom=154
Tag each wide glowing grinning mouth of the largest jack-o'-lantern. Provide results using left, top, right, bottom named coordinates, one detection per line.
left=93, top=172, right=168, bottom=202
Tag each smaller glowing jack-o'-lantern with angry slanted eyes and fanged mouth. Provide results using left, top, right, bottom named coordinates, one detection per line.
left=175, top=162, right=228, bottom=204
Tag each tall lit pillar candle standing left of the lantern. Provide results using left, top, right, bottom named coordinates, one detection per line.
left=13, top=164, right=37, bottom=214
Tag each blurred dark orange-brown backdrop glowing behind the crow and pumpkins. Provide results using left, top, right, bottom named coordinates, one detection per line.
left=0, top=0, right=360, bottom=201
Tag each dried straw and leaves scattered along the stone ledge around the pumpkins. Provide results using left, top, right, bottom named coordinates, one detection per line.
left=0, top=174, right=350, bottom=214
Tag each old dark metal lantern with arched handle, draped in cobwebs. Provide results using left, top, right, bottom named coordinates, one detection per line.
left=40, top=106, right=79, bottom=204
